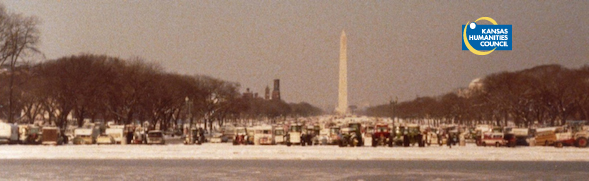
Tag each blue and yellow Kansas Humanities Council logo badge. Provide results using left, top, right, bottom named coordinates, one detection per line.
left=462, top=17, right=512, bottom=55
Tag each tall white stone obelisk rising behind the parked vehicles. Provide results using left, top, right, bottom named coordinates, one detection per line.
left=335, top=30, right=348, bottom=115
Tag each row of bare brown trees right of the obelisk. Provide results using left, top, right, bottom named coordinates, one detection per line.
left=366, top=65, right=589, bottom=127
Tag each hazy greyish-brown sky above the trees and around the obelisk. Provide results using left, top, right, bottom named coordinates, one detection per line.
left=3, top=0, right=589, bottom=108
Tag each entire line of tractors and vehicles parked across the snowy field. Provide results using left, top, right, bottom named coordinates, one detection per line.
left=0, top=121, right=589, bottom=147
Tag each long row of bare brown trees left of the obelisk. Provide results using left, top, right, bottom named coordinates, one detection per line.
left=0, top=54, right=321, bottom=129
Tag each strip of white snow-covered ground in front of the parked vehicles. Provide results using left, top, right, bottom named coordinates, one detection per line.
left=0, top=144, right=589, bottom=161
